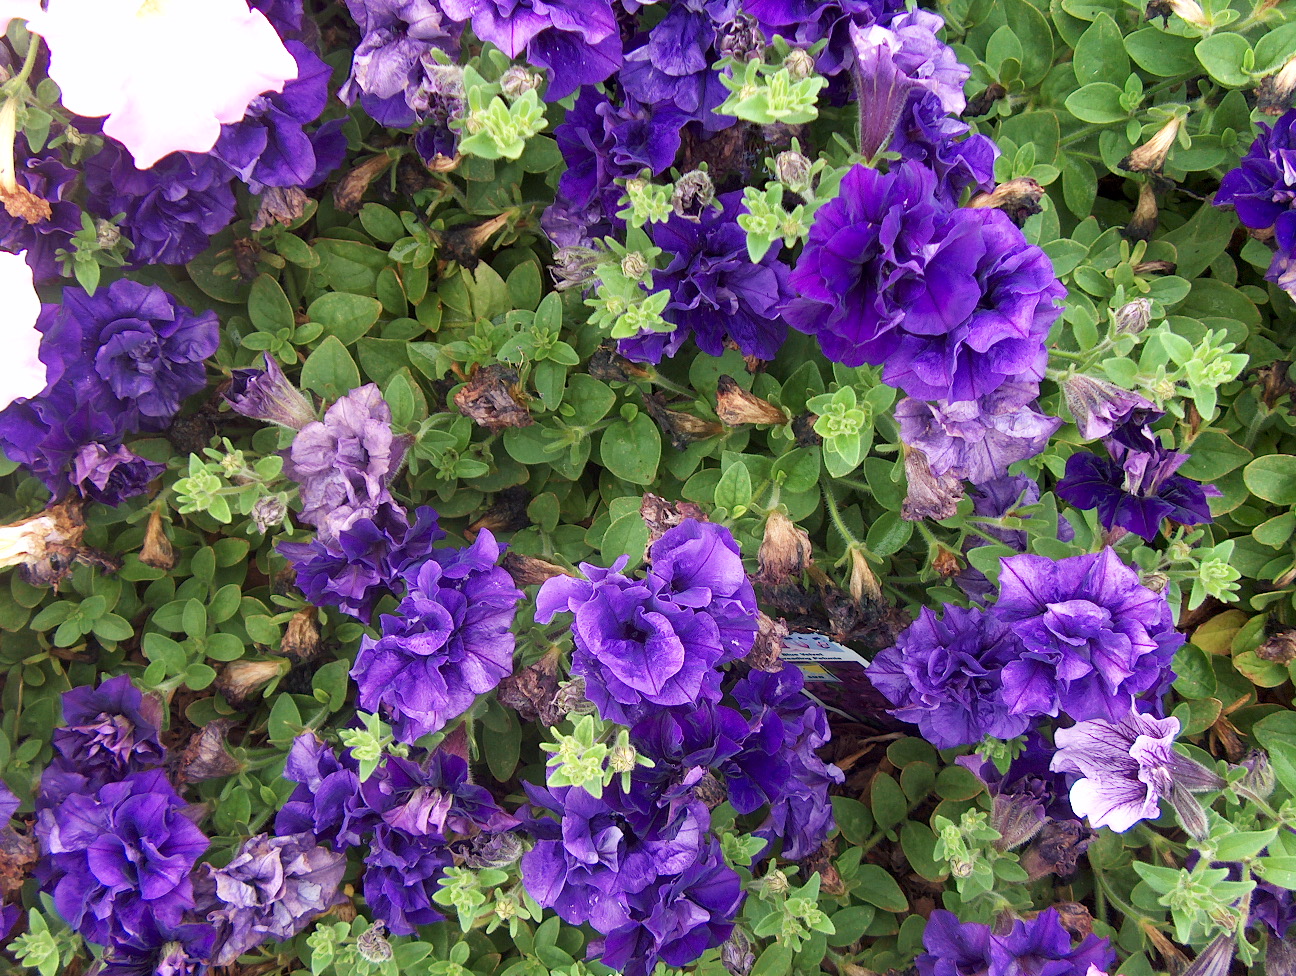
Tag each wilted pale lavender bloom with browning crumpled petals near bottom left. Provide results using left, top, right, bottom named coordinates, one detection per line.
left=205, top=833, right=346, bottom=966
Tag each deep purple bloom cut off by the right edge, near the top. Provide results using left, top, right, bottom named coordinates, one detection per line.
left=1214, top=109, right=1296, bottom=290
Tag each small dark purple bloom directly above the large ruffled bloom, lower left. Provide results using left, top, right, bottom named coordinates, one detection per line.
left=53, top=674, right=166, bottom=785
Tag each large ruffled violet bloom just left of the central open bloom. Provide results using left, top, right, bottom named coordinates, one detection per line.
left=351, top=529, right=522, bottom=743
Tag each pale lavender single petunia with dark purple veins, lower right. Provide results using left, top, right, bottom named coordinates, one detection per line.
left=1051, top=712, right=1223, bottom=832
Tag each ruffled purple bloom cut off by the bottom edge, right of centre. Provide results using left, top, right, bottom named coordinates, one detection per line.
left=914, top=907, right=1116, bottom=976
